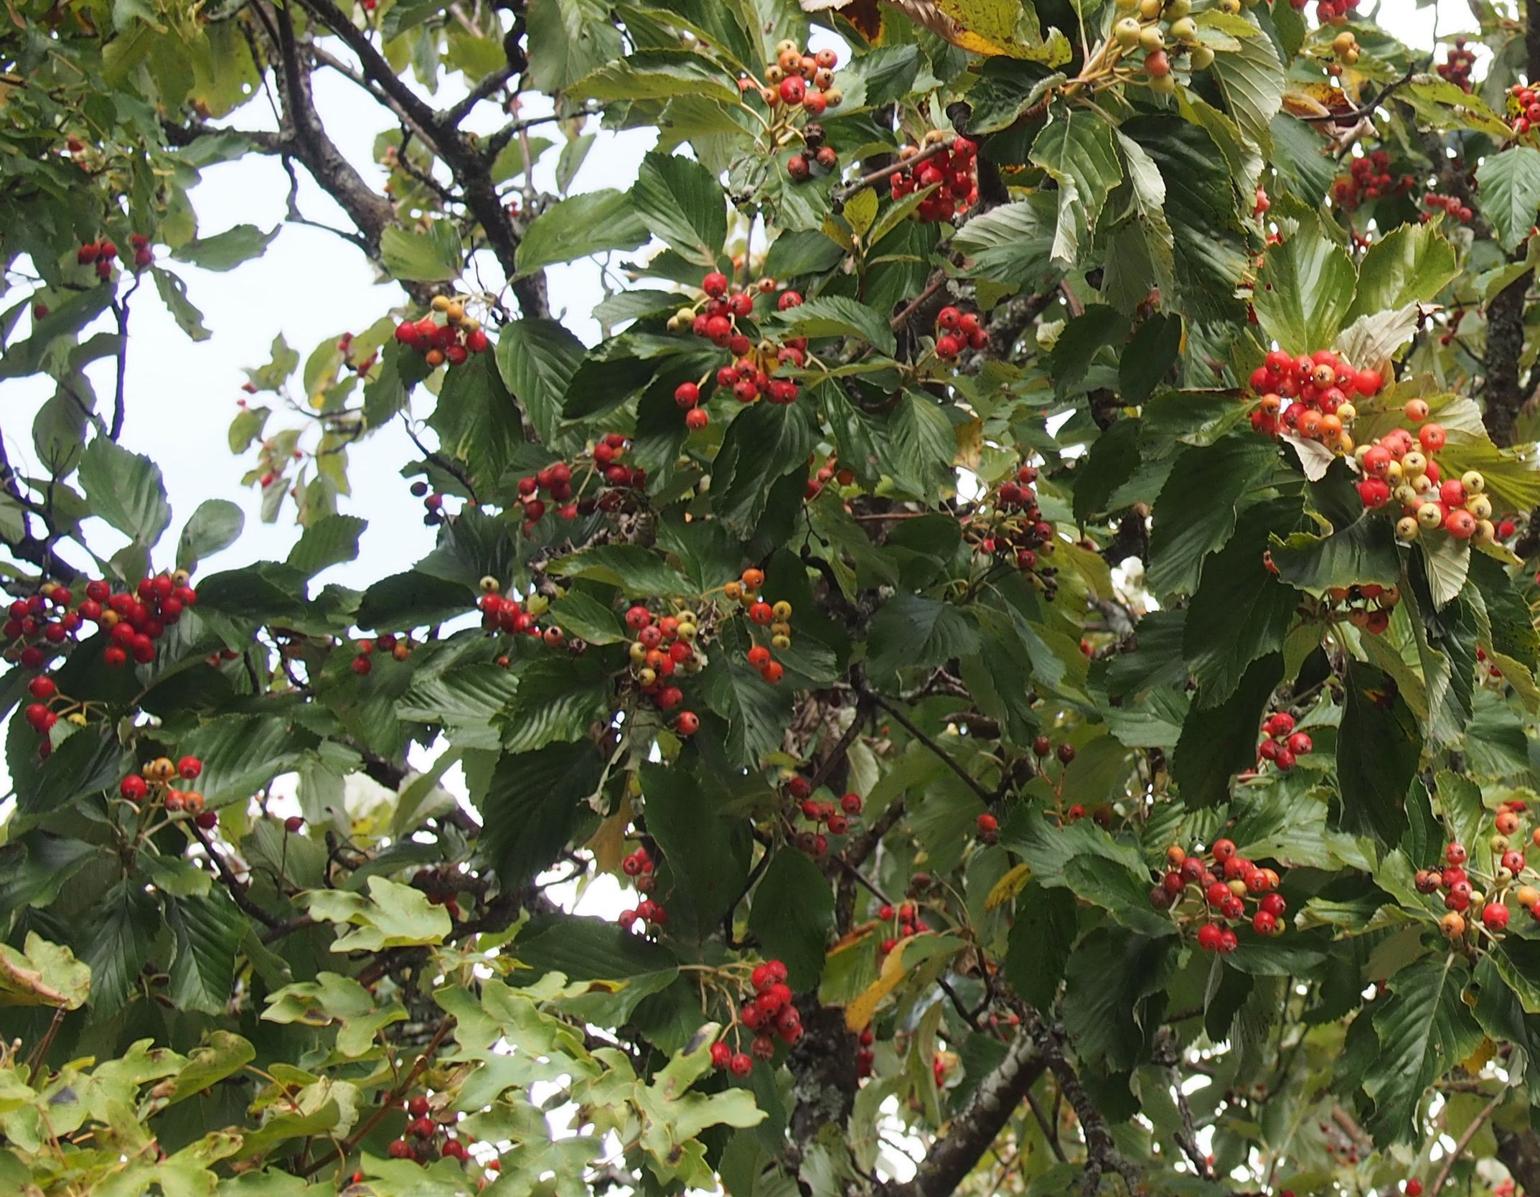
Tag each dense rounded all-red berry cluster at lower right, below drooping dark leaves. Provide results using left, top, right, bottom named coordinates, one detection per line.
left=1150, top=838, right=1287, bottom=954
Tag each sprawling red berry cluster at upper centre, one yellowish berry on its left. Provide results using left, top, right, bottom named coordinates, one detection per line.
left=668, top=270, right=807, bottom=419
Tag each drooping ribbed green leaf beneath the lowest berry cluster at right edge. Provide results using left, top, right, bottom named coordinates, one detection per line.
left=1363, top=952, right=1481, bottom=1143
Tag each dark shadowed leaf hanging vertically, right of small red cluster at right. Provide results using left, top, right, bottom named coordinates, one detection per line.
left=1337, top=659, right=1423, bottom=844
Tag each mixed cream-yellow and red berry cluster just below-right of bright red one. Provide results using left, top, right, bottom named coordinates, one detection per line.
left=1355, top=399, right=1497, bottom=544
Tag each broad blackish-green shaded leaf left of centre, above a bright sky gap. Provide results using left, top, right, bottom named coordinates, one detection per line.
left=480, top=741, right=601, bottom=892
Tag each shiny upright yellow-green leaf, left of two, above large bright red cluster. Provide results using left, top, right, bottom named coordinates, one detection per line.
left=1252, top=220, right=1355, bottom=354
